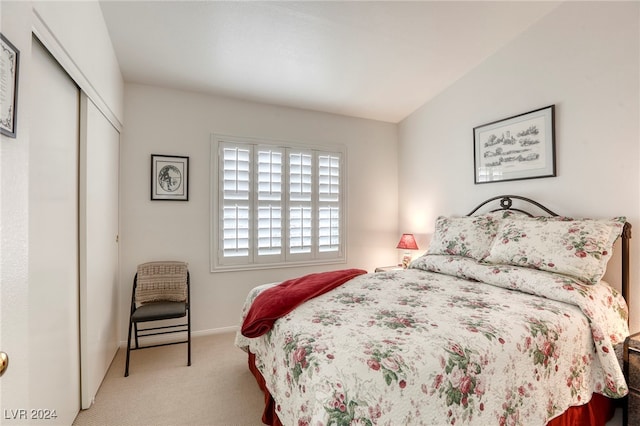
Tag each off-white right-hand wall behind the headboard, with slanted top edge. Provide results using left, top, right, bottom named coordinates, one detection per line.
left=398, top=2, right=640, bottom=331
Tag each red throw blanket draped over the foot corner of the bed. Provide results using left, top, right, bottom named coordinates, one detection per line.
left=241, top=269, right=367, bottom=337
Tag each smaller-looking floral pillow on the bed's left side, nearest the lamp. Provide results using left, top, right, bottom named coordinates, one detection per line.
left=426, top=211, right=511, bottom=260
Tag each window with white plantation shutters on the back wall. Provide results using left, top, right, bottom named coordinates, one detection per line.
left=211, top=135, right=346, bottom=271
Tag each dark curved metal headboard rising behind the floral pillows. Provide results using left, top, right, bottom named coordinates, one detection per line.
left=467, top=195, right=631, bottom=304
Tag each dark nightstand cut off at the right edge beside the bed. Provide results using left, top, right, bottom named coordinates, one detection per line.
left=622, top=333, right=640, bottom=426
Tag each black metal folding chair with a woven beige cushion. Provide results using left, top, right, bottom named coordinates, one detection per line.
left=124, top=261, right=191, bottom=377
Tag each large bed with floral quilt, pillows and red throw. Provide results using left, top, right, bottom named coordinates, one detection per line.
left=236, top=196, right=630, bottom=426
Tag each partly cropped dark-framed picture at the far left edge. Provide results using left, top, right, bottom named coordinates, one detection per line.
left=0, top=33, right=20, bottom=138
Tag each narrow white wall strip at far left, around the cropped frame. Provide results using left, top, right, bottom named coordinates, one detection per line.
left=0, top=2, right=31, bottom=408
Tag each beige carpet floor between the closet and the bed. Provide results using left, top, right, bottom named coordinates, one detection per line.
left=73, top=333, right=264, bottom=426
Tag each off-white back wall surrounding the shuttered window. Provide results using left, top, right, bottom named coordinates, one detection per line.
left=120, top=84, right=399, bottom=340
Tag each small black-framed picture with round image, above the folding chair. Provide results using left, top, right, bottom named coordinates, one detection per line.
left=151, top=154, right=189, bottom=201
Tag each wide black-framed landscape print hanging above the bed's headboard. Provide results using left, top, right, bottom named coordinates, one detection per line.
left=473, top=105, right=556, bottom=184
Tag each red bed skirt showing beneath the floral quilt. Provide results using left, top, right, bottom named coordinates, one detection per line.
left=249, top=352, right=616, bottom=426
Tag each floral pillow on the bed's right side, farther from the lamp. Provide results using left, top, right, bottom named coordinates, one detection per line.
left=485, top=217, right=626, bottom=284
